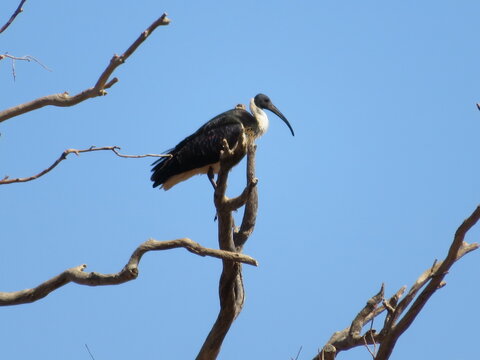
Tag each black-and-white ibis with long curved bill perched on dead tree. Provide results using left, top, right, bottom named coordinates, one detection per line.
left=150, top=94, right=295, bottom=190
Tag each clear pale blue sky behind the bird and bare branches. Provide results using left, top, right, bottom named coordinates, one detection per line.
left=0, top=0, right=480, bottom=360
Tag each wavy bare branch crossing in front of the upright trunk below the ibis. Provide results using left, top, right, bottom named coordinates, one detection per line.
left=0, top=238, right=258, bottom=306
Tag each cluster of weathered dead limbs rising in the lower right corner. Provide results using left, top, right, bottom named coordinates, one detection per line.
left=313, top=206, right=480, bottom=360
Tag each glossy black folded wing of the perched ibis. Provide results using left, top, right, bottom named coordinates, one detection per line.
left=150, top=109, right=252, bottom=187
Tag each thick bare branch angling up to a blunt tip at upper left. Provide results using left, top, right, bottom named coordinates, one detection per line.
left=0, top=14, right=170, bottom=122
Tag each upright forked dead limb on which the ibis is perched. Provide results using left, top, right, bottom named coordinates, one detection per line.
left=196, top=141, right=258, bottom=360
